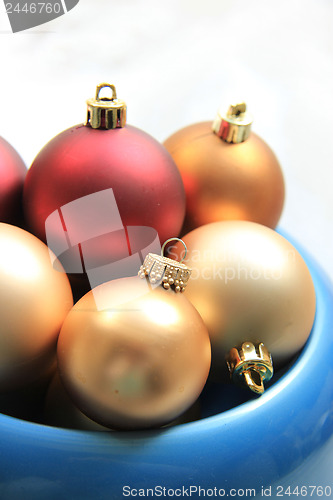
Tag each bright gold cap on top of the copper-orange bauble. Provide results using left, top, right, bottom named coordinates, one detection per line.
left=212, top=102, right=253, bottom=144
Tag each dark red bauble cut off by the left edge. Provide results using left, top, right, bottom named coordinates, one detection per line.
left=0, top=137, right=27, bottom=224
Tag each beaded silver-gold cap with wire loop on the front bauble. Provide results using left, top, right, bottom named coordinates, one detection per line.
left=138, top=238, right=192, bottom=292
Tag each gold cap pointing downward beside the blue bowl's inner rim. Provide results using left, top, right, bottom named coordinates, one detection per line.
left=226, top=342, right=273, bottom=394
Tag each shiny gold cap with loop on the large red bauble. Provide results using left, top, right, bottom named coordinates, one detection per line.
left=86, top=83, right=127, bottom=129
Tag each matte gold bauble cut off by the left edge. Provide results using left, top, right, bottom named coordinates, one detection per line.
left=0, top=223, right=73, bottom=392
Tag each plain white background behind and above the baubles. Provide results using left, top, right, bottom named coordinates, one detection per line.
left=0, top=0, right=333, bottom=278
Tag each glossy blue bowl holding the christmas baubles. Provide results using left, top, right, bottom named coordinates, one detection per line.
left=0, top=238, right=333, bottom=500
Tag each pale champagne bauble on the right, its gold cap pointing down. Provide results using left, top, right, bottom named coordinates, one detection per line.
left=173, top=221, right=316, bottom=392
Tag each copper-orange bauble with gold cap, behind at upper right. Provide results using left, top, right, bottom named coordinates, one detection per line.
left=164, top=103, right=284, bottom=233
